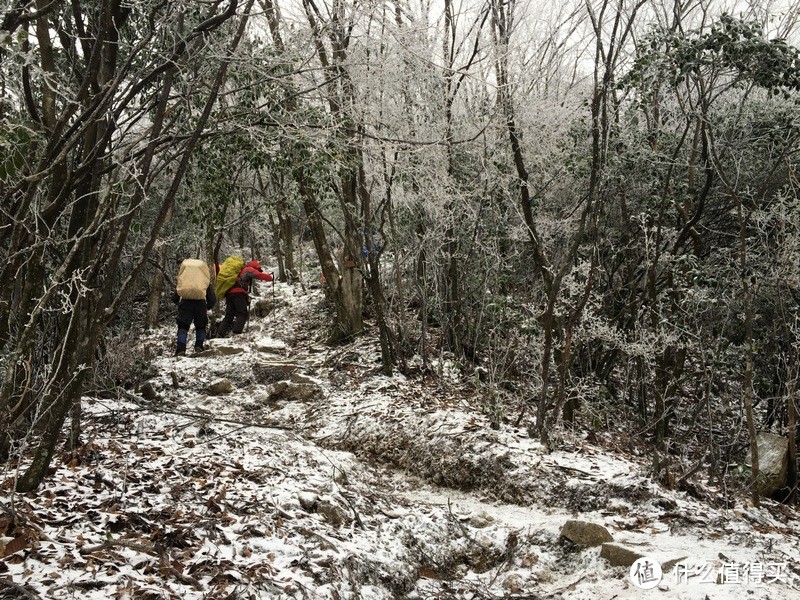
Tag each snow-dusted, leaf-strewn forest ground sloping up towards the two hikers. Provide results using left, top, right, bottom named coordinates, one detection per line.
left=0, top=287, right=800, bottom=600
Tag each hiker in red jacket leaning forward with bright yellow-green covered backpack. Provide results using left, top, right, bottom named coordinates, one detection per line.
left=214, top=256, right=272, bottom=337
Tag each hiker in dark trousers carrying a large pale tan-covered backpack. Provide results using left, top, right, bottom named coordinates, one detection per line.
left=172, top=258, right=217, bottom=356
